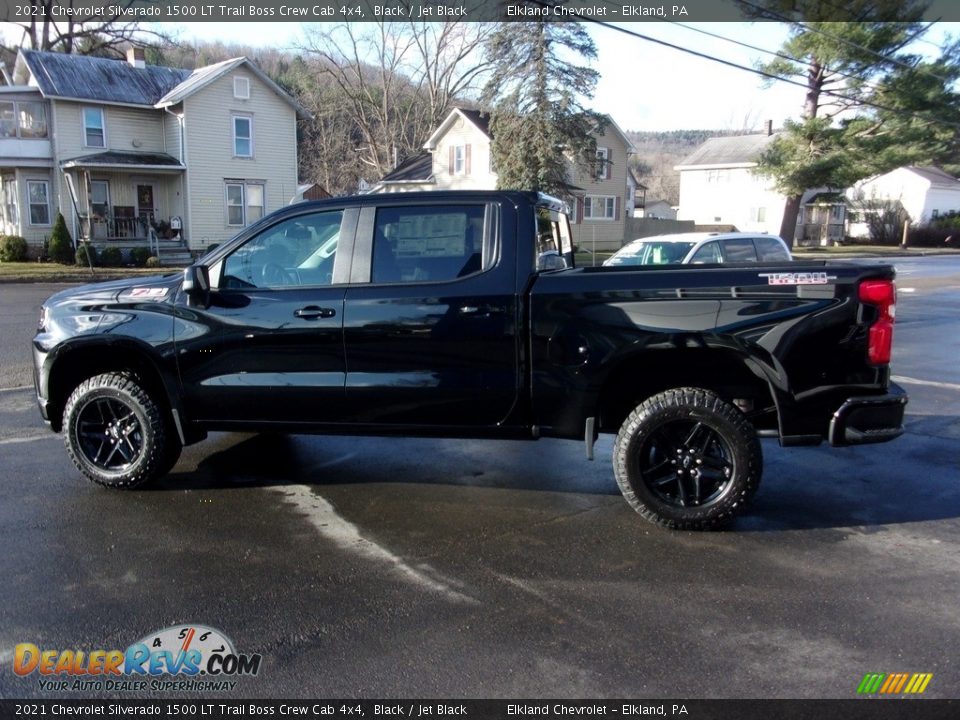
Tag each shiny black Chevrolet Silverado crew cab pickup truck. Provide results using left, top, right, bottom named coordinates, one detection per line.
left=33, top=192, right=907, bottom=529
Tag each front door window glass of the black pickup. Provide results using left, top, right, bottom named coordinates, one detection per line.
left=219, top=210, right=343, bottom=290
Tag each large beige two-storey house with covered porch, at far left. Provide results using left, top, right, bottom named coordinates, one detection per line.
left=0, top=49, right=305, bottom=254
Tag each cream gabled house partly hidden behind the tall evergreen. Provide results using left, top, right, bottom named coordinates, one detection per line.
left=370, top=108, right=634, bottom=250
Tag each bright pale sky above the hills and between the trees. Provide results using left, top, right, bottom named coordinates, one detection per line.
left=7, top=22, right=960, bottom=131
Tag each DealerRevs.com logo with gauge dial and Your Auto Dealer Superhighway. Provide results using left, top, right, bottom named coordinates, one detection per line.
left=13, top=625, right=262, bottom=692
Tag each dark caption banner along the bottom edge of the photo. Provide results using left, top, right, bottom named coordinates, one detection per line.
left=0, top=699, right=960, bottom=720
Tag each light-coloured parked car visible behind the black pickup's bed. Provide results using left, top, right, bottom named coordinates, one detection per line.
left=603, top=233, right=793, bottom=266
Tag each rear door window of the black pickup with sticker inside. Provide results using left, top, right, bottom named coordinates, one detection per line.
left=371, top=205, right=486, bottom=283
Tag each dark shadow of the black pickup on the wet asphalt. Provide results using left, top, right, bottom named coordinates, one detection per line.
left=148, top=417, right=960, bottom=533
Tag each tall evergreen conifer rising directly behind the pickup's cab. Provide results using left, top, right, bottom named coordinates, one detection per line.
left=483, top=19, right=606, bottom=195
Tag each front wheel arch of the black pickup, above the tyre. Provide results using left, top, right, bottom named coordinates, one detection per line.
left=46, top=338, right=182, bottom=433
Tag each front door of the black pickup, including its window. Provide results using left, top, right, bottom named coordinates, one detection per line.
left=175, top=205, right=356, bottom=426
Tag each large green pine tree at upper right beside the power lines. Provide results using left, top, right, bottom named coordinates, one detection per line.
left=758, top=0, right=960, bottom=245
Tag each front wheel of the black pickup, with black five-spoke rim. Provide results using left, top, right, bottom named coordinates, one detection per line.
left=63, top=373, right=180, bottom=488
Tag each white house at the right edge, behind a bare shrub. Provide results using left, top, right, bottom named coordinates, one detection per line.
left=846, top=167, right=960, bottom=237
